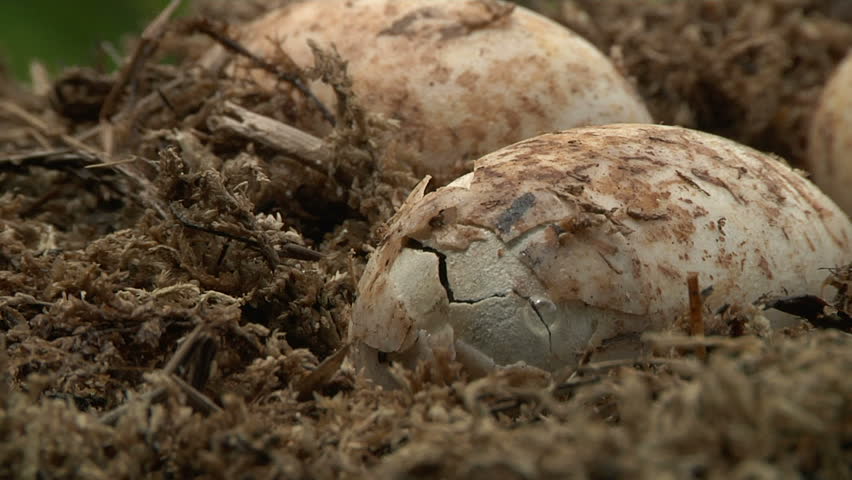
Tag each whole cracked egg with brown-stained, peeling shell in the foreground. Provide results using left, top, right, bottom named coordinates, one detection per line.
left=349, top=125, right=852, bottom=384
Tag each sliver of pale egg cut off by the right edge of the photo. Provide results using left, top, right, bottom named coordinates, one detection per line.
left=808, top=52, right=852, bottom=215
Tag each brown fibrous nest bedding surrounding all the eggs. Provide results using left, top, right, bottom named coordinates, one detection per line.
left=0, top=0, right=852, bottom=479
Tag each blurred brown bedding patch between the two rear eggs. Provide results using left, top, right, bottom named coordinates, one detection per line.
left=556, top=0, right=852, bottom=166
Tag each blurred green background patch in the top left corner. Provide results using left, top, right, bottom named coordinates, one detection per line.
left=0, top=0, right=181, bottom=81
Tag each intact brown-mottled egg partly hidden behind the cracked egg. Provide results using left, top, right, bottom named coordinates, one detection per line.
left=220, top=0, right=652, bottom=184
